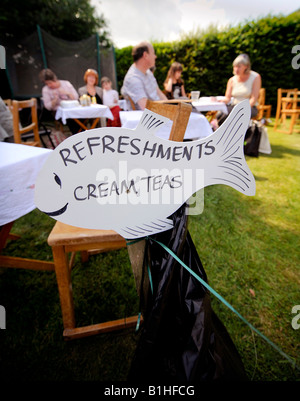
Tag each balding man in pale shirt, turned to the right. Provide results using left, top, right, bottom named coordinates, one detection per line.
left=121, top=42, right=167, bottom=110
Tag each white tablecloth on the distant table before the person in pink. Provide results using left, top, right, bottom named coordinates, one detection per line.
left=55, top=104, right=114, bottom=124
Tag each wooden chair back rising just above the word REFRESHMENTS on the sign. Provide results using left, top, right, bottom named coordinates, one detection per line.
left=146, top=100, right=192, bottom=142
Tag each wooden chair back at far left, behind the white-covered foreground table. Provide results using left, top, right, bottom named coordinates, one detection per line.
left=12, top=98, right=41, bottom=146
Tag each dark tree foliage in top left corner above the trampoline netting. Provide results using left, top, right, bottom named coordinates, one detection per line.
left=0, top=0, right=110, bottom=45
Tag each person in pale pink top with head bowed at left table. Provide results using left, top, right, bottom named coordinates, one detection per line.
left=39, top=68, right=80, bottom=134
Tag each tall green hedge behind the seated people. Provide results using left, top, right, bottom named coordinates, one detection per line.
left=115, top=10, right=300, bottom=115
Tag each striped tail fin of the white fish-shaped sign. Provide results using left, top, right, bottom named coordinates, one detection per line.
left=209, top=100, right=255, bottom=196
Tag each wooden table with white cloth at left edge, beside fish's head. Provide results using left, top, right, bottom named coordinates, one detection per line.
left=0, top=142, right=54, bottom=270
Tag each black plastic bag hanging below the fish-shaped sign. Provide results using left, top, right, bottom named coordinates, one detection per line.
left=128, top=205, right=247, bottom=383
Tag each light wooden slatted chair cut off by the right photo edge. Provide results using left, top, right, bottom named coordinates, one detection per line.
left=274, top=88, right=300, bottom=134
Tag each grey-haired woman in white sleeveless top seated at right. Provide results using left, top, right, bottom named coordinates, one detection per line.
left=219, top=54, right=261, bottom=125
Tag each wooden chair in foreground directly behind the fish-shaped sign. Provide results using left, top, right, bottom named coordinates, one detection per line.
left=48, top=102, right=192, bottom=339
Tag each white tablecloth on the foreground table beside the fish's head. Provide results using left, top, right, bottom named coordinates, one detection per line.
left=0, top=142, right=52, bottom=226
